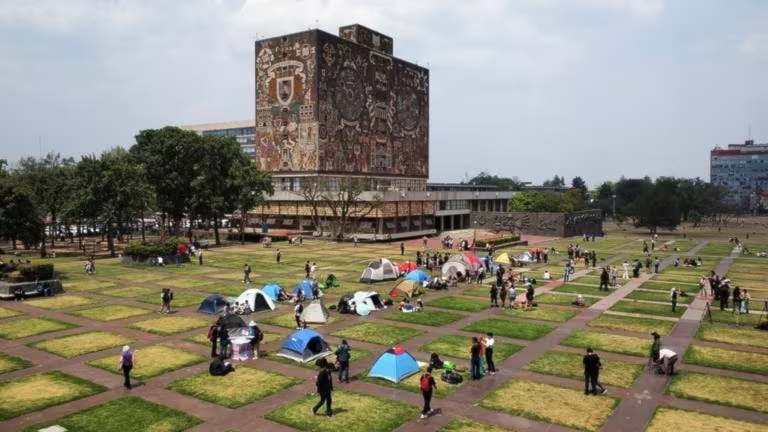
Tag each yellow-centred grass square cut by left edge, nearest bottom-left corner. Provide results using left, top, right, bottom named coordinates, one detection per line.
left=0, top=371, right=106, bottom=421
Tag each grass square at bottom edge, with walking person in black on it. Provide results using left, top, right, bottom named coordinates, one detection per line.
left=268, top=390, right=419, bottom=432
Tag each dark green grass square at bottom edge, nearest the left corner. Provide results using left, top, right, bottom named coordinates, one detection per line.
left=24, top=396, right=202, bottom=432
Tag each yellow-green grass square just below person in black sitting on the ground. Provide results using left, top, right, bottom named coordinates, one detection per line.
left=167, top=366, right=301, bottom=408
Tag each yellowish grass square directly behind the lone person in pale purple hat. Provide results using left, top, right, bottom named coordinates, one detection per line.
left=88, top=345, right=207, bottom=379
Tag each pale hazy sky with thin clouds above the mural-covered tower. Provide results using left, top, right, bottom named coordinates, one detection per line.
left=0, top=0, right=768, bottom=186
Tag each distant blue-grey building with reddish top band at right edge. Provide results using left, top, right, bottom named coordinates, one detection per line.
left=710, top=140, right=768, bottom=209
